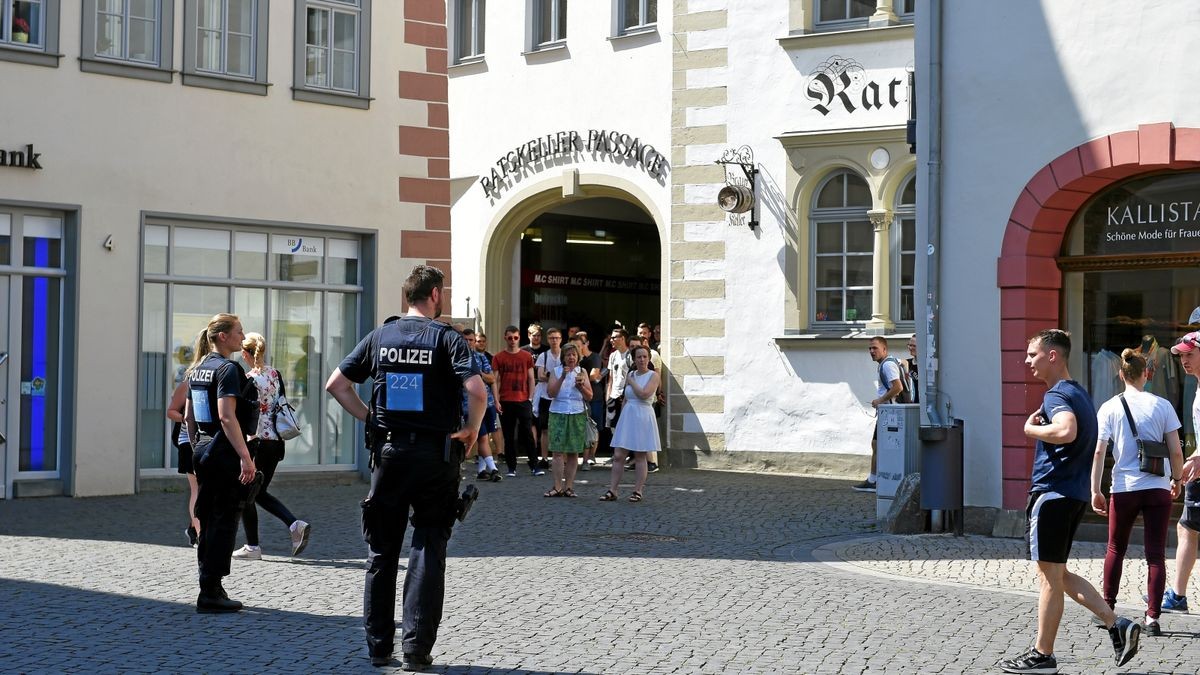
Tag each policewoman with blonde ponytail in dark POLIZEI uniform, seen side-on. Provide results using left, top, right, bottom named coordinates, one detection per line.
left=185, top=313, right=262, bottom=614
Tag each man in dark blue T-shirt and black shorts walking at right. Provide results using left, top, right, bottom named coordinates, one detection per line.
left=1000, top=328, right=1141, bottom=673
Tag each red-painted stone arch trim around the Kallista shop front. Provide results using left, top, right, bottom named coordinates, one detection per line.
left=996, top=123, right=1200, bottom=509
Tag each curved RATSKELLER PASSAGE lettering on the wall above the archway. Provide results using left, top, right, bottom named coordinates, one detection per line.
left=479, top=129, right=666, bottom=195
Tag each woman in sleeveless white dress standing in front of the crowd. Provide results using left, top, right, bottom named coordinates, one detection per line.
left=600, top=347, right=661, bottom=502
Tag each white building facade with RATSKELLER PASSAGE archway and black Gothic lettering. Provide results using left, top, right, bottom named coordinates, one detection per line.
left=448, top=0, right=916, bottom=476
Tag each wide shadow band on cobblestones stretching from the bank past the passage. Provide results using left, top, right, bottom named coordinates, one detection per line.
left=0, top=470, right=875, bottom=559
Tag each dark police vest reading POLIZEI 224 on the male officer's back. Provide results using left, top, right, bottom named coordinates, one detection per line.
left=371, top=318, right=462, bottom=434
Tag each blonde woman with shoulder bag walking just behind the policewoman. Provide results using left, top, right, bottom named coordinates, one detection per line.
left=233, top=333, right=312, bottom=560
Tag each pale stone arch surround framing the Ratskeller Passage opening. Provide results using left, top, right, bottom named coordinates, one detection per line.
left=479, top=173, right=671, bottom=341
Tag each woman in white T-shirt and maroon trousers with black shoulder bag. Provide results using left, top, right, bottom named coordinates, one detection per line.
left=1092, top=350, right=1183, bottom=635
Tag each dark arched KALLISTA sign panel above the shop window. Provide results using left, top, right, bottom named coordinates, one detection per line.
left=1084, top=172, right=1200, bottom=256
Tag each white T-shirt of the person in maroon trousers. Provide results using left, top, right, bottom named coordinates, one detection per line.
left=1096, top=389, right=1180, bottom=492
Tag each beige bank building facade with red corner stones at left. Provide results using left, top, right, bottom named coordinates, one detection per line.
left=0, top=0, right=450, bottom=497
